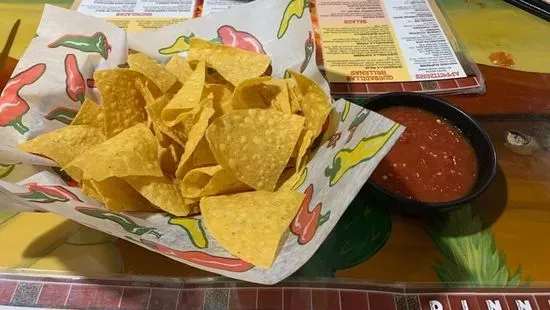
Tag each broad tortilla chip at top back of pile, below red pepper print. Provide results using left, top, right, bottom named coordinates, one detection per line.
left=188, top=38, right=271, bottom=86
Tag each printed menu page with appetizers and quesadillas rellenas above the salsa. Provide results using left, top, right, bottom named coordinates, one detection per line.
left=316, top=0, right=466, bottom=83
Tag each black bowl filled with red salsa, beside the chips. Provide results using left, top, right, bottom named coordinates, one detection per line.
left=365, top=93, right=497, bottom=215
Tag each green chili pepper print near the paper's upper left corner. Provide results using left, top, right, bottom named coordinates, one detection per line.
left=48, top=32, right=111, bottom=59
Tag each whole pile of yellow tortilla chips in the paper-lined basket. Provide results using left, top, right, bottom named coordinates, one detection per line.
left=19, top=38, right=331, bottom=268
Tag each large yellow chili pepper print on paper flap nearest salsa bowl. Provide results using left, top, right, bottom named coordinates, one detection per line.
left=325, top=124, right=399, bottom=186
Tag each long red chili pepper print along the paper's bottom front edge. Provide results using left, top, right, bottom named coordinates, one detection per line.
left=141, top=239, right=254, bottom=272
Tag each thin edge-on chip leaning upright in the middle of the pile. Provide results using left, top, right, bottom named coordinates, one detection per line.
left=176, top=96, right=214, bottom=179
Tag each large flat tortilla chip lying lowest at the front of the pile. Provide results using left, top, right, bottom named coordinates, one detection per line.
left=200, top=191, right=304, bottom=268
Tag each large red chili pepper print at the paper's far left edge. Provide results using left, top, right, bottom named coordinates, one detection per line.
left=0, top=63, right=46, bottom=134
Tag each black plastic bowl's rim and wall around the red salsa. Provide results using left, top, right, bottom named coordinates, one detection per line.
left=363, top=93, right=497, bottom=216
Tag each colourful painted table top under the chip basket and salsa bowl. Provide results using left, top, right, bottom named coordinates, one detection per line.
left=0, top=0, right=550, bottom=286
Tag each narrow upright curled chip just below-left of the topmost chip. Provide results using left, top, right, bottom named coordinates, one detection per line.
left=161, top=61, right=205, bottom=127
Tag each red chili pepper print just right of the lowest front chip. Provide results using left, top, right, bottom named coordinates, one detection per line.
left=290, top=184, right=330, bottom=244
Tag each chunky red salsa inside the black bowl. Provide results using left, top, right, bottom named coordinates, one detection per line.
left=372, top=106, right=478, bottom=202
